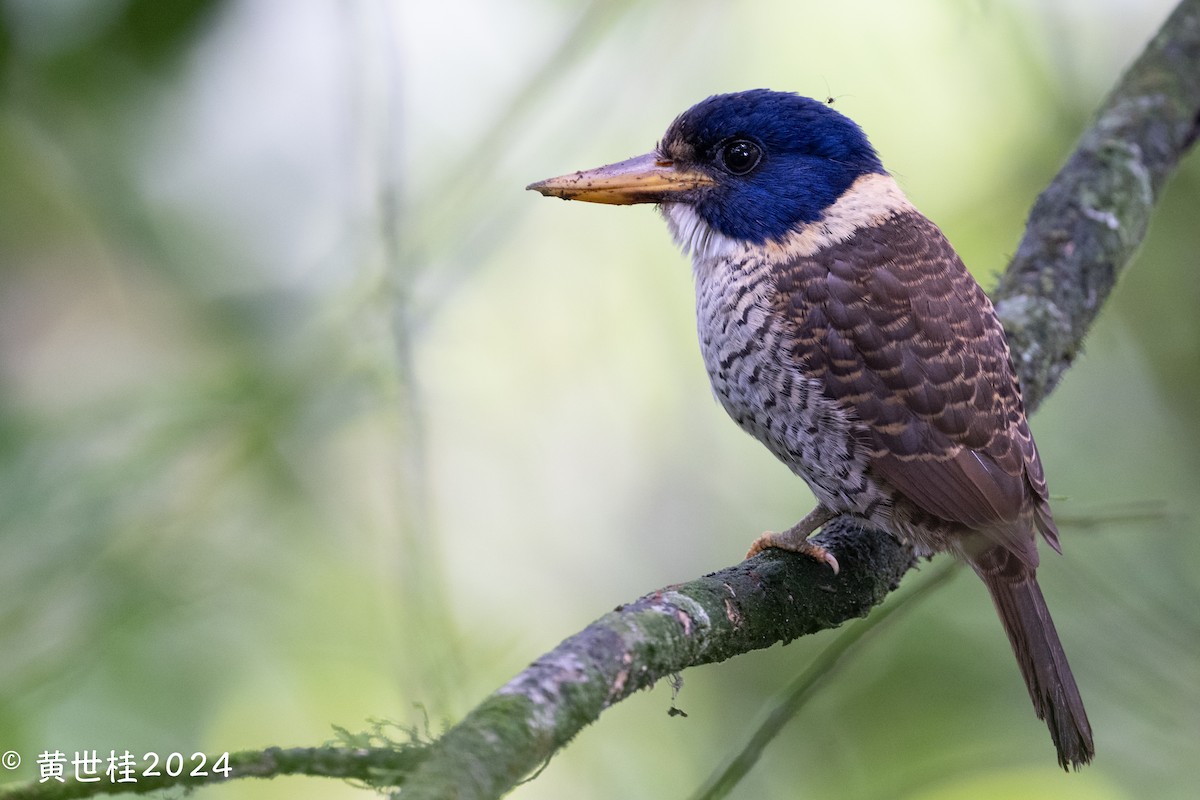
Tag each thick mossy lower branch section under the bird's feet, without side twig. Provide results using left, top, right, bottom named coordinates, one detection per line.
left=403, top=517, right=913, bottom=800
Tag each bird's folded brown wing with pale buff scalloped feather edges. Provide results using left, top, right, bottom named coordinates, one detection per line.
left=775, top=212, right=1056, bottom=564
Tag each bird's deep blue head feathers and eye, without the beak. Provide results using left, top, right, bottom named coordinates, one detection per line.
left=659, top=89, right=884, bottom=243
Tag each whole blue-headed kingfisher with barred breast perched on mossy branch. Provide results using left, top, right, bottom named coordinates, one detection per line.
left=528, top=89, right=1094, bottom=769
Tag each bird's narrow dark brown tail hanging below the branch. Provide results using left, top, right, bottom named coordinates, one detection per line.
left=971, top=547, right=1096, bottom=769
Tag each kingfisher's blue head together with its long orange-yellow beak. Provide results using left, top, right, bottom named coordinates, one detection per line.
left=529, top=89, right=884, bottom=243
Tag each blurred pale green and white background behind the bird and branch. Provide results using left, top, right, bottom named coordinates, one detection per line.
left=0, top=0, right=1200, bottom=800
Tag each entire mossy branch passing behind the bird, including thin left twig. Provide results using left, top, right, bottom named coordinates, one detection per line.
left=0, top=0, right=1200, bottom=800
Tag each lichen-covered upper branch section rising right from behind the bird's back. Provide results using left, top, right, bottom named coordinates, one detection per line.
left=992, top=0, right=1200, bottom=411
